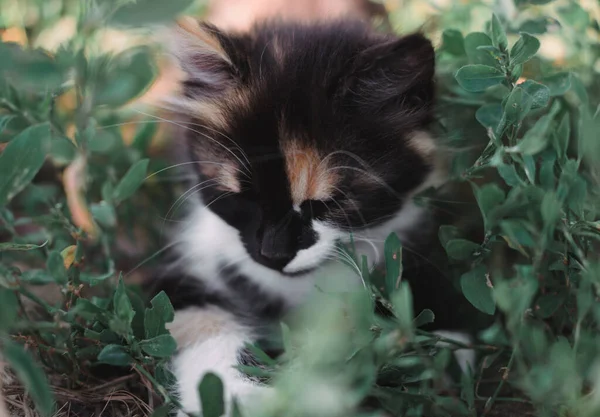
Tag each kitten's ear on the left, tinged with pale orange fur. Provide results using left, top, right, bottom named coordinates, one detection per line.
left=166, top=18, right=238, bottom=109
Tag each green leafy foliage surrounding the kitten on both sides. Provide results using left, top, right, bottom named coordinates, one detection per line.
left=0, top=0, right=600, bottom=417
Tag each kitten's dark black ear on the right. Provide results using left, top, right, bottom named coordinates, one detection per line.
left=344, top=34, right=435, bottom=108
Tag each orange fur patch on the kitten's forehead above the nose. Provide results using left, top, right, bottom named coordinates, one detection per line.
left=283, top=142, right=338, bottom=204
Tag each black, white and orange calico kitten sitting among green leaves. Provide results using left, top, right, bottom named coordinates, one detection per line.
left=150, top=20, right=440, bottom=412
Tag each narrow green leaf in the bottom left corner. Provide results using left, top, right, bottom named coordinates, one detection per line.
left=2, top=339, right=55, bottom=416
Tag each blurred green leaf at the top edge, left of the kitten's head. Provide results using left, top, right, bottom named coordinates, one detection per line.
left=110, top=0, right=194, bottom=26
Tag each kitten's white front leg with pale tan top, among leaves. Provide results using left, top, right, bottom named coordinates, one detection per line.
left=169, top=307, right=266, bottom=416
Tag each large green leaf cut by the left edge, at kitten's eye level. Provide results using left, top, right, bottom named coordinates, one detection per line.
left=0, top=123, right=50, bottom=206
